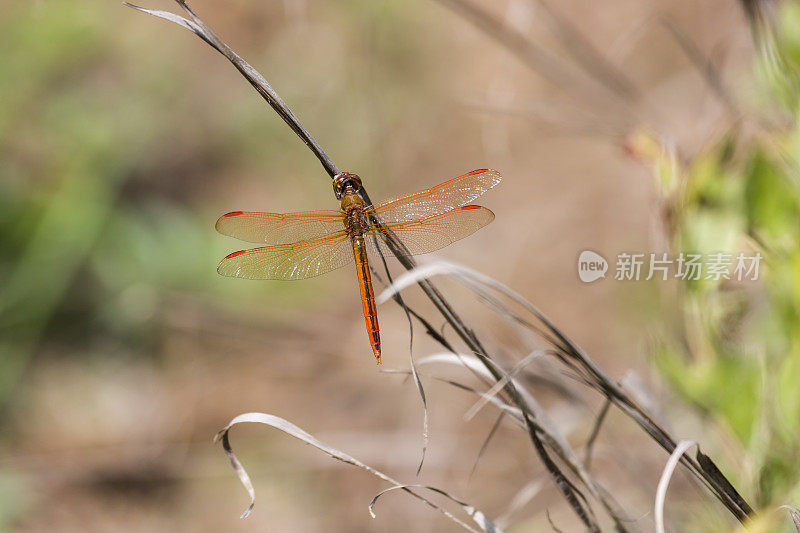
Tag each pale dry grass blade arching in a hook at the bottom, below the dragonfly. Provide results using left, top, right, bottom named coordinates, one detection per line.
left=215, top=413, right=500, bottom=533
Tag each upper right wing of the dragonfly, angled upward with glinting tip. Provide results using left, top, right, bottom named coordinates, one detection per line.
left=367, top=169, right=501, bottom=222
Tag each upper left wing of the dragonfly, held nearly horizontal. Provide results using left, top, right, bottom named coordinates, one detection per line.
left=216, top=211, right=344, bottom=244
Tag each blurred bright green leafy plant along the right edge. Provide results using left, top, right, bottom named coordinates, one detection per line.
left=657, top=3, right=800, bottom=520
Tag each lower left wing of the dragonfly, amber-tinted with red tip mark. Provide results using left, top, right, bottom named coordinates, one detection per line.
left=217, top=230, right=353, bottom=280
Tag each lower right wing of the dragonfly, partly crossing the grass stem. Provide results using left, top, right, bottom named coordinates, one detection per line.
left=365, top=205, right=494, bottom=256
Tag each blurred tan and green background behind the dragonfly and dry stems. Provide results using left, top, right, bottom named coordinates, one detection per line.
left=0, top=0, right=752, bottom=532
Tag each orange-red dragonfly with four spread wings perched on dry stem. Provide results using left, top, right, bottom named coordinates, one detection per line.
left=216, top=169, right=501, bottom=364
